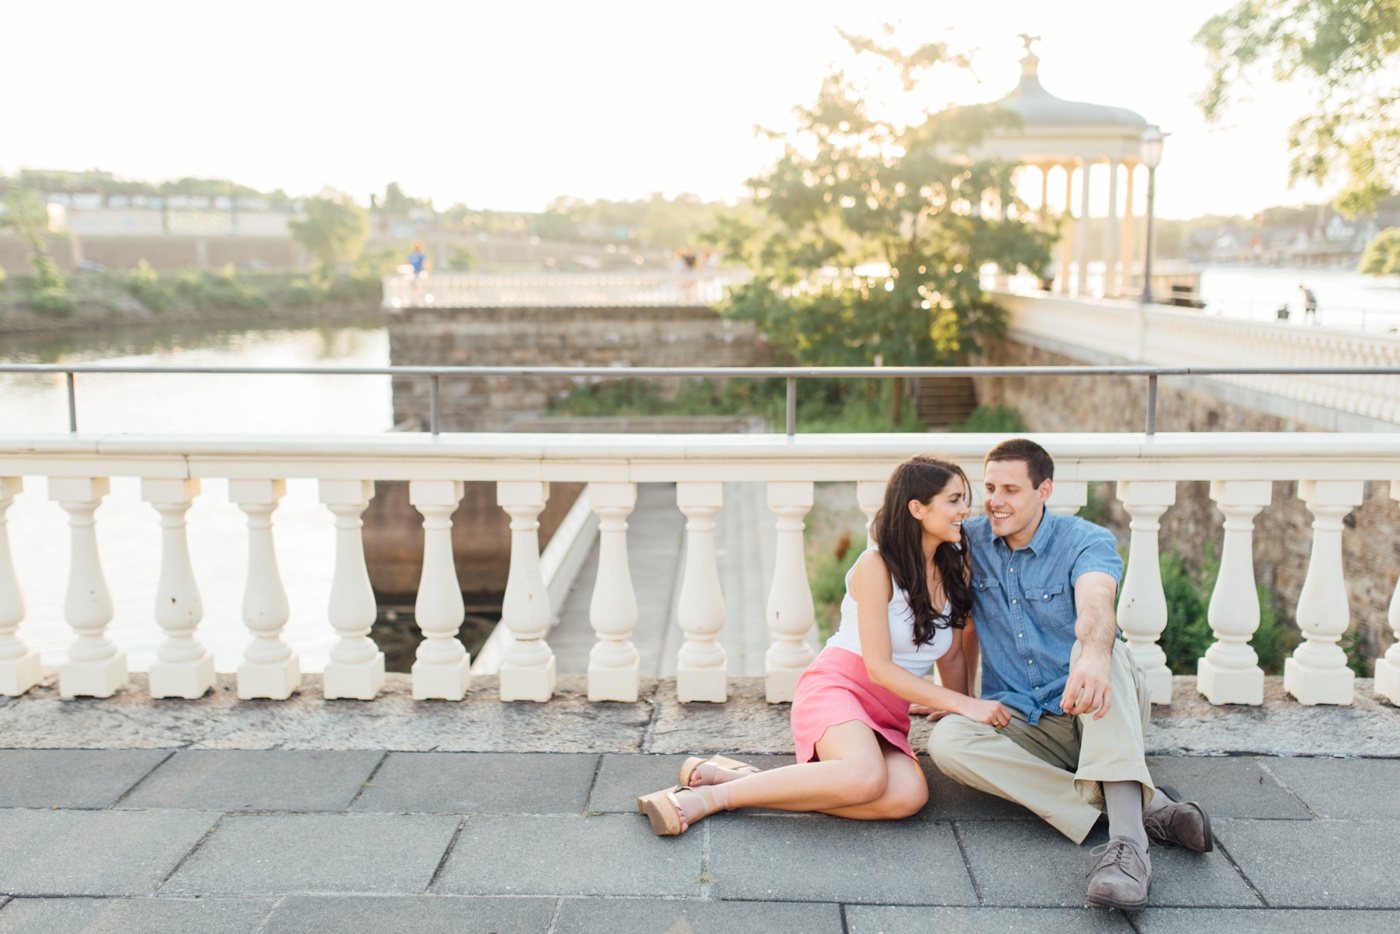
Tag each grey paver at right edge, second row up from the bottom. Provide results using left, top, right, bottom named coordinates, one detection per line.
left=1215, top=823, right=1400, bottom=909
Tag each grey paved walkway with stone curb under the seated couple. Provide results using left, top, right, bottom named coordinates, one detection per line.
left=0, top=676, right=1400, bottom=934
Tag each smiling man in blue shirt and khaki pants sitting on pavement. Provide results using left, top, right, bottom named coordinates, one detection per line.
left=928, top=438, right=1212, bottom=909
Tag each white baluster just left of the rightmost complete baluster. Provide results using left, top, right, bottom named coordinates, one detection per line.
left=1196, top=480, right=1274, bottom=706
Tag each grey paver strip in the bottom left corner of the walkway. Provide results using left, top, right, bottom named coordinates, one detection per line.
left=0, top=898, right=274, bottom=934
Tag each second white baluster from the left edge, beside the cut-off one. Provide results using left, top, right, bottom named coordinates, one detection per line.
left=49, top=478, right=126, bottom=697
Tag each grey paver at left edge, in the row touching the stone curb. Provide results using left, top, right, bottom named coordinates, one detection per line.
left=0, top=749, right=171, bottom=808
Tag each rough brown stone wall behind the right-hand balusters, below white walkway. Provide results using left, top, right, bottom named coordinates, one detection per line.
left=977, top=340, right=1400, bottom=674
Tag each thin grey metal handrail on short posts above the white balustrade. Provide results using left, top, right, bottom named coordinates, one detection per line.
left=0, top=363, right=1400, bottom=437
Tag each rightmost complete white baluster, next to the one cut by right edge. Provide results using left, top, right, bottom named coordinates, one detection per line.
left=1284, top=480, right=1362, bottom=704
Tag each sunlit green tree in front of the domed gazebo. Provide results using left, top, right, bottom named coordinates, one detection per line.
left=711, top=29, right=1051, bottom=423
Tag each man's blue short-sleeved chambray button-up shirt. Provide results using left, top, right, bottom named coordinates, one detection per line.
left=963, top=511, right=1123, bottom=725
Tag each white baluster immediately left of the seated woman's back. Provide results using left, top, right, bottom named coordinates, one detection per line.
left=764, top=480, right=816, bottom=704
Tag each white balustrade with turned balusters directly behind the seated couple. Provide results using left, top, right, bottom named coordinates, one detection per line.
left=0, top=433, right=1400, bottom=704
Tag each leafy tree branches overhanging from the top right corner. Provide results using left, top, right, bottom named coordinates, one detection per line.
left=1196, top=0, right=1400, bottom=216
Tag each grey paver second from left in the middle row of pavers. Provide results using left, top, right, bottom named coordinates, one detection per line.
left=161, top=814, right=458, bottom=895
